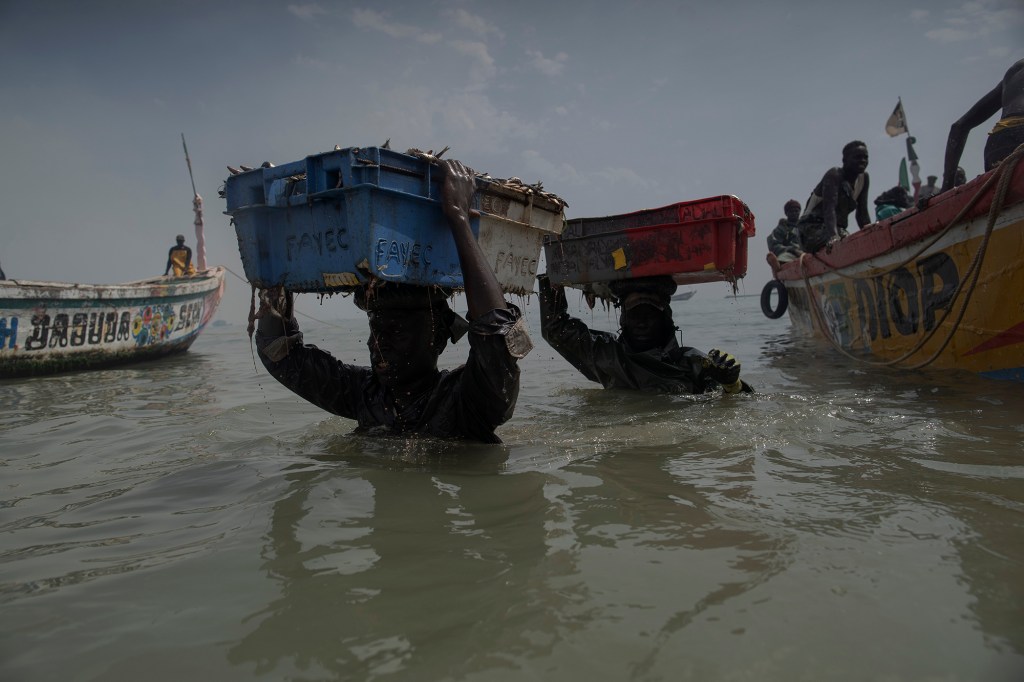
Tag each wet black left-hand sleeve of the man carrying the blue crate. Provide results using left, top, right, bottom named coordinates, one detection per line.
left=256, top=317, right=370, bottom=419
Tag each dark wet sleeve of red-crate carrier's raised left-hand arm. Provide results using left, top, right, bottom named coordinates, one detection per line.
left=539, top=279, right=621, bottom=386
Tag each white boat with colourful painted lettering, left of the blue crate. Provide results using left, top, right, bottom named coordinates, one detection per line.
left=0, top=267, right=224, bottom=379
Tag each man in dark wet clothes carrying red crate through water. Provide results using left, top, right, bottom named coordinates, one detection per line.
left=538, top=274, right=753, bottom=393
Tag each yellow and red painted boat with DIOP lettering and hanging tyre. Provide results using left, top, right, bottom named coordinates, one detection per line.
left=761, top=146, right=1024, bottom=381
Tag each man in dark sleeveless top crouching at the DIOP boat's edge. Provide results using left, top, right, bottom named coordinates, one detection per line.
left=800, top=140, right=871, bottom=253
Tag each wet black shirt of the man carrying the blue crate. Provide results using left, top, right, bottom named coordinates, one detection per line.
left=256, top=306, right=530, bottom=442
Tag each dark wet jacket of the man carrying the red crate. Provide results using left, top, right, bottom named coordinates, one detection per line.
left=540, top=286, right=719, bottom=393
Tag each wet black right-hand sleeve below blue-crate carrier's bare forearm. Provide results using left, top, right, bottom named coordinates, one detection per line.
left=458, top=304, right=532, bottom=439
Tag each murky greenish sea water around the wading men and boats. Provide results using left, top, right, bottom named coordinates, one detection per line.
left=0, top=292, right=1024, bottom=682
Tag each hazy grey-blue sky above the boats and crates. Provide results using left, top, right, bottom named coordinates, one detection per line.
left=0, top=0, right=1024, bottom=321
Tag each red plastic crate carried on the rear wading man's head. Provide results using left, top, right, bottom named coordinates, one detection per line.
left=544, top=196, right=755, bottom=289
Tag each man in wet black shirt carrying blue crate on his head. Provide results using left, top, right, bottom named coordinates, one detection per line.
left=256, top=161, right=532, bottom=442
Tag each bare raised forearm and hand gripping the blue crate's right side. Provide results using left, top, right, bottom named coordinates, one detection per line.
left=441, top=160, right=506, bottom=319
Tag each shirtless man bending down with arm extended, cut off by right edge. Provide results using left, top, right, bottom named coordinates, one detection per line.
left=942, top=59, right=1024, bottom=191
